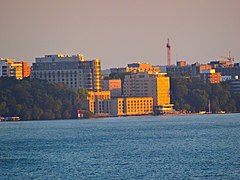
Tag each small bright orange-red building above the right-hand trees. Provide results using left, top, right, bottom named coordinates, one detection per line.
left=200, top=69, right=221, bottom=84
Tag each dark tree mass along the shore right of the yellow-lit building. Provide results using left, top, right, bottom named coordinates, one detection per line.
left=171, top=77, right=240, bottom=113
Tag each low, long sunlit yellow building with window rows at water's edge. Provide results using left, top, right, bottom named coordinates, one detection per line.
left=111, top=97, right=153, bottom=116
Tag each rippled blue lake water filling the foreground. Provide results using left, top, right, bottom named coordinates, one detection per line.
left=0, top=114, right=240, bottom=179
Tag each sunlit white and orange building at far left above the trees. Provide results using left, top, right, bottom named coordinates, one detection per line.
left=0, top=58, right=30, bottom=79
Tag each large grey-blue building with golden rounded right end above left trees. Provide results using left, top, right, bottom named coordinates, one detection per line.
left=31, top=54, right=101, bottom=92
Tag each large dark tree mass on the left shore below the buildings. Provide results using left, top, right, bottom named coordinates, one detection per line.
left=0, top=77, right=87, bottom=120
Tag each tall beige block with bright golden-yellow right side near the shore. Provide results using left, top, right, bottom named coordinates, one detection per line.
left=123, top=72, right=170, bottom=109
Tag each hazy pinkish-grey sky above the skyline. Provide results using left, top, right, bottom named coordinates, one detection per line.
left=0, top=0, right=240, bottom=69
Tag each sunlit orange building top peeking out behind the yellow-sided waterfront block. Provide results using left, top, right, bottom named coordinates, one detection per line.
left=110, top=62, right=160, bottom=73
